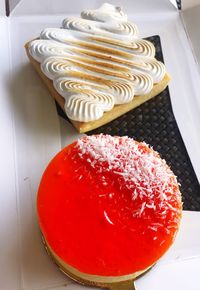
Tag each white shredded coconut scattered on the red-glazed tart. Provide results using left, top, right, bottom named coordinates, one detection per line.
left=76, top=134, right=181, bottom=231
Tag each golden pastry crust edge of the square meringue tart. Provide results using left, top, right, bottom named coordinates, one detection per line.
left=25, top=42, right=170, bottom=133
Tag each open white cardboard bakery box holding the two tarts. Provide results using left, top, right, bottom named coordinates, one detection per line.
left=0, top=0, right=200, bottom=290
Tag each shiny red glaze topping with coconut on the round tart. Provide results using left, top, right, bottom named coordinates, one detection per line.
left=37, top=135, right=182, bottom=276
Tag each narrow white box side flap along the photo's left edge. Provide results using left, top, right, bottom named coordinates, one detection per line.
left=0, top=17, right=20, bottom=290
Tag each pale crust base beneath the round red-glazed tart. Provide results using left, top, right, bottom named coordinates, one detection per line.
left=42, top=236, right=153, bottom=289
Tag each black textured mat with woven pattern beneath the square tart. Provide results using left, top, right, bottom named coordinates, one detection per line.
left=57, top=35, right=200, bottom=210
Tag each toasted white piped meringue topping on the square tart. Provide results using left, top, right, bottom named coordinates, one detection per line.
left=29, top=4, right=166, bottom=122
